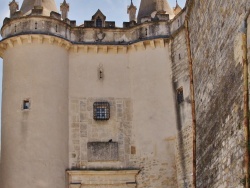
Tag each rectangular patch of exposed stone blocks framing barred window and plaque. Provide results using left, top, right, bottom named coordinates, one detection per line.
left=70, top=98, right=132, bottom=169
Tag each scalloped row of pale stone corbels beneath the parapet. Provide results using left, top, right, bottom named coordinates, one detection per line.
left=0, top=34, right=169, bottom=57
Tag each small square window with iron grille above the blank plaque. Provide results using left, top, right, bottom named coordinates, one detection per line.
left=93, top=102, right=110, bottom=120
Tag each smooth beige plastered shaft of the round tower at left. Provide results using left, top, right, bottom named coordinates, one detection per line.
left=1, top=41, right=68, bottom=188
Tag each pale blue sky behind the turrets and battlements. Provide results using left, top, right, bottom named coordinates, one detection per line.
left=0, top=0, right=186, bottom=135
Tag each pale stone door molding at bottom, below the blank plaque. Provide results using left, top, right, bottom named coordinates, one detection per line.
left=67, top=170, right=139, bottom=188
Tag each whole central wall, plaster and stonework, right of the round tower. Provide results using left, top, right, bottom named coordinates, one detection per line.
left=69, top=40, right=179, bottom=188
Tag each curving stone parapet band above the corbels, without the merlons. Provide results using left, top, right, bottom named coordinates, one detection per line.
left=1, top=11, right=188, bottom=45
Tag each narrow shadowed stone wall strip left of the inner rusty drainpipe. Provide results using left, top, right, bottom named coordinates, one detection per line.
left=171, top=27, right=193, bottom=187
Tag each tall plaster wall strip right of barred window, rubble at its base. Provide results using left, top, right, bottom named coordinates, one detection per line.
left=129, top=44, right=176, bottom=188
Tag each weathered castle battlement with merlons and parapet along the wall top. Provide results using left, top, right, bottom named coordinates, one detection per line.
left=1, top=2, right=185, bottom=45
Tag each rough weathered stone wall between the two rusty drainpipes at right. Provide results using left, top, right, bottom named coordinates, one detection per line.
left=189, top=0, right=250, bottom=188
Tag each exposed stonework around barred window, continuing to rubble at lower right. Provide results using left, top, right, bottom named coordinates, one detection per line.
left=69, top=98, right=176, bottom=188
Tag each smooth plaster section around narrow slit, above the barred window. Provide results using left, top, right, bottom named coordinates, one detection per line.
left=69, top=49, right=130, bottom=98
